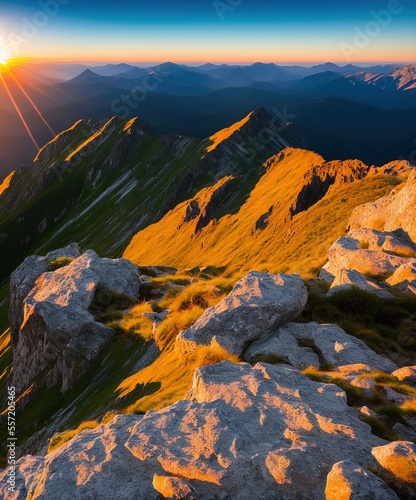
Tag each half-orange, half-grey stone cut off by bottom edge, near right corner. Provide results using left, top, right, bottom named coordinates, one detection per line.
left=325, top=460, right=399, bottom=500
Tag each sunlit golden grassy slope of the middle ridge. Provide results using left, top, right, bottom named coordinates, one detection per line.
left=124, top=148, right=405, bottom=276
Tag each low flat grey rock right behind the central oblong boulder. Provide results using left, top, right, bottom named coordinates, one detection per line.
left=244, top=323, right=397, bottom=373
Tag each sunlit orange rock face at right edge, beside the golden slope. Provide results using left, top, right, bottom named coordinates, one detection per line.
left=349, top=169, right=416, bottom=241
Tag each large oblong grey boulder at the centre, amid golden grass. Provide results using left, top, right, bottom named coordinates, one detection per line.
left=175, top=272, right=308, bottom=354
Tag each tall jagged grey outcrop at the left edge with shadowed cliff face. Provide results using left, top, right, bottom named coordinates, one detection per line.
left=10, top=245, right=140, bottom=394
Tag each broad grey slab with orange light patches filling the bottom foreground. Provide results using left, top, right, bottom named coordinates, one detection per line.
left=0, top=362, right=388, bottom=500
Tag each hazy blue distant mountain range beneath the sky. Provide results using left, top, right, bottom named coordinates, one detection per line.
left=0, top=63, right=416, bottom=177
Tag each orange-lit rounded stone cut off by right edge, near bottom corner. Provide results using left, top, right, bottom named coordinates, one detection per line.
left=371, top=441, right=416, bottom=485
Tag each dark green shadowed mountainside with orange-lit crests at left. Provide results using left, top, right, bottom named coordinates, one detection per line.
left=0, top=109, right=289, bottom=279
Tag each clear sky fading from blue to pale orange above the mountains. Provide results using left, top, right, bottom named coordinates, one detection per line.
left=0, top=0, right=416, bottom=64
